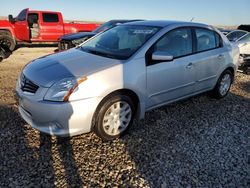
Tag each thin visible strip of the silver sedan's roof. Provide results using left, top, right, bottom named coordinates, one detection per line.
left=124, top=20, right=208, bottom=27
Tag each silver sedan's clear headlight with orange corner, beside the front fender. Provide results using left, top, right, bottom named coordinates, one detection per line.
left=44, top=77, right=87, bottom=102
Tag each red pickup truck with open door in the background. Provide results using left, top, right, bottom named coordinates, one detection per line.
left=0, top=8, right=99, bottom=51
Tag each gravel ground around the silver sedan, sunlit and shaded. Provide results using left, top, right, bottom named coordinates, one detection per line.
left=0, top=48, right=250, bottom=187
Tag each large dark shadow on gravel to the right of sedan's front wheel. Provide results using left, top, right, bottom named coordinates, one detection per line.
left=121, top=93, right=250, bottom=187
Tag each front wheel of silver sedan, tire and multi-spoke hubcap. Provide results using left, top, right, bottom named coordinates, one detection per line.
left=93, top=94, right=135, bottom=141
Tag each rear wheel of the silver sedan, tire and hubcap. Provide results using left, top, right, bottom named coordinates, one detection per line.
left=211, top=70, right=233, bottom=99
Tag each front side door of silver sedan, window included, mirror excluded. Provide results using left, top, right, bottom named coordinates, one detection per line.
left=146, top=28, right=195, bottom=108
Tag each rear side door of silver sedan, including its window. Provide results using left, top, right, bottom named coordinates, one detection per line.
left=194, top=28, right=226, bottom=92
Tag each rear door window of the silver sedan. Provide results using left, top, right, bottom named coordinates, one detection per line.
left=195, top=28, right=220, bottom=52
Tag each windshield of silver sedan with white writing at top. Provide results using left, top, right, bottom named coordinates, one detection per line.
left=80, top=25, right=160, bottom=59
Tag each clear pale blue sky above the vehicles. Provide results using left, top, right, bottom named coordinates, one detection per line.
left=0, top=0, right=250, bottom=25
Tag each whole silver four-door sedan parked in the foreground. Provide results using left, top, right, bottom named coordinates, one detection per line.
left=16, top=21, right=239, bottom=140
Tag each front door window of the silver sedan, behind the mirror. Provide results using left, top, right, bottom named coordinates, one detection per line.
left=153, top=28, right=193, bottom=58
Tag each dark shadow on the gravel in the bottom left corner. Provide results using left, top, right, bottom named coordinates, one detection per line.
left=0, top=105, right=54, bottom=187
